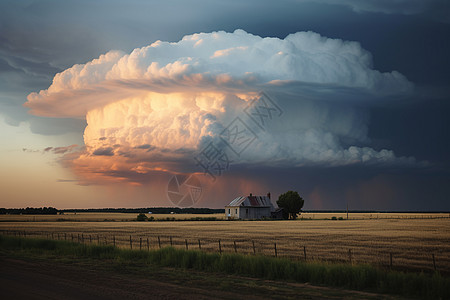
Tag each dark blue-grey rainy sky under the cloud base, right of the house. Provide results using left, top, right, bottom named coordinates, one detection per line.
left=224, top=166, right=450, bottom=211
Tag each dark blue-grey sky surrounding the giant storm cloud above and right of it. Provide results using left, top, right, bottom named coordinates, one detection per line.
left=0, top=0, right=450, bottom=211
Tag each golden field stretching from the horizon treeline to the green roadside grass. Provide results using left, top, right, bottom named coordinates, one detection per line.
left=0, top=214, right=450, bottom=275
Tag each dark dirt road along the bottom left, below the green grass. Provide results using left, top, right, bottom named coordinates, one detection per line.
left=0, top=254, right=400, bottom=300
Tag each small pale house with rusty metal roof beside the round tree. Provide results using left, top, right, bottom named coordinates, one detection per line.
left=225, top=193, right=274, bottom=219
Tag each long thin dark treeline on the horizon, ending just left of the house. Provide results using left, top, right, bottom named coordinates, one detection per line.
left=60, top=207, right=225, bottom=214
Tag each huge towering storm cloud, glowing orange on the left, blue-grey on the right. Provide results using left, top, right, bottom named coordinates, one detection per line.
left=25, top=30, right=412, bottom=185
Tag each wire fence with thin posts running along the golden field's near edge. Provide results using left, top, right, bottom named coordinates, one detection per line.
left=0, top=230, right=450, bottom=275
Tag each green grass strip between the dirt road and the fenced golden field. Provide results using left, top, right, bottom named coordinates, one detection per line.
left=0, top=235, right=450, bottom=299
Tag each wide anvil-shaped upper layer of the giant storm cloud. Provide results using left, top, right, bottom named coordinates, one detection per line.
left=25, top=30, right=412, bottom=117
